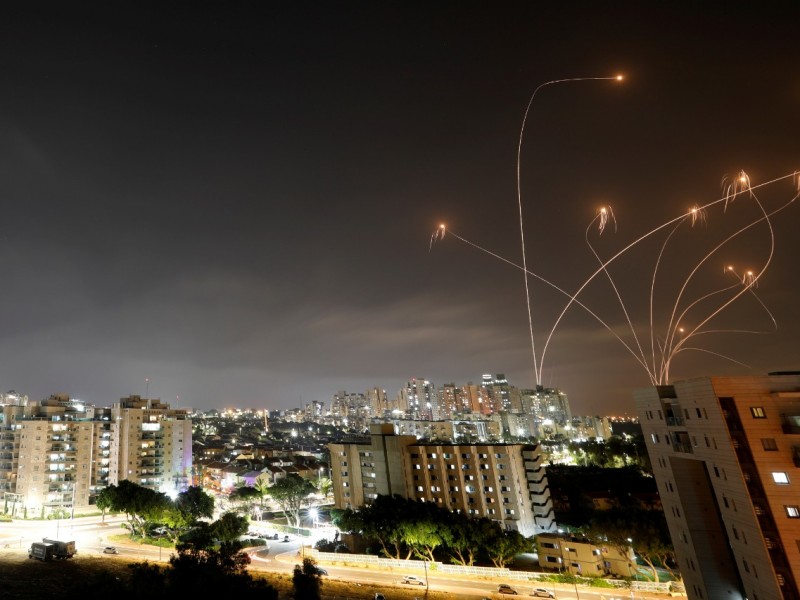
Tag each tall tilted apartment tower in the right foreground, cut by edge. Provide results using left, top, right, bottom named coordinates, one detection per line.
left=635, top=372, right=800, bottom=600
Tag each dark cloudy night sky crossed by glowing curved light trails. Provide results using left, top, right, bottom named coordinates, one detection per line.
left=0, top=0, right=800, bottom=414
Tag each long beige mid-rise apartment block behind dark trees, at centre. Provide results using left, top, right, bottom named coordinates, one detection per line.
left=329, top=424, right=556, bottom=536
